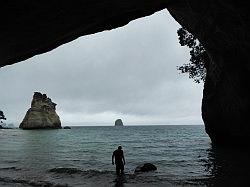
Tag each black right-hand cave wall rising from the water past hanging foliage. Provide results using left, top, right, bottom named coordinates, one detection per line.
left=168, top=0, right=250, bottom=146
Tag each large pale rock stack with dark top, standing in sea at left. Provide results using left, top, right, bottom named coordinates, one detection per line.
left=19, top=92, right=62, bottom=129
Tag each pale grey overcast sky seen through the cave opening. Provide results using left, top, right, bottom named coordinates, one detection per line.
left=0, top=10, right=203, bottom=125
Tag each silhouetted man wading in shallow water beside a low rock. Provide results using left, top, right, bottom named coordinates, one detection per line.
left=112, top=146, right=125, bottom=175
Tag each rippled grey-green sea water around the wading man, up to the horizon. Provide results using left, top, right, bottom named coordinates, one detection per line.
left=0, top=125, right=250, bottom=187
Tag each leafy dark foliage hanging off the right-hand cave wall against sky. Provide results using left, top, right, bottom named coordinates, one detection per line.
left=177, top=28, right=209, bottom=83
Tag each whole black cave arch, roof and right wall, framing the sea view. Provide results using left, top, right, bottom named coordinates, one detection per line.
left=0, top=0, right=250, bottom=146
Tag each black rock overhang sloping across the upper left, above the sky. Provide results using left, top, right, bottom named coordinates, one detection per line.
left=0, top=0, right=174, bottom=67
